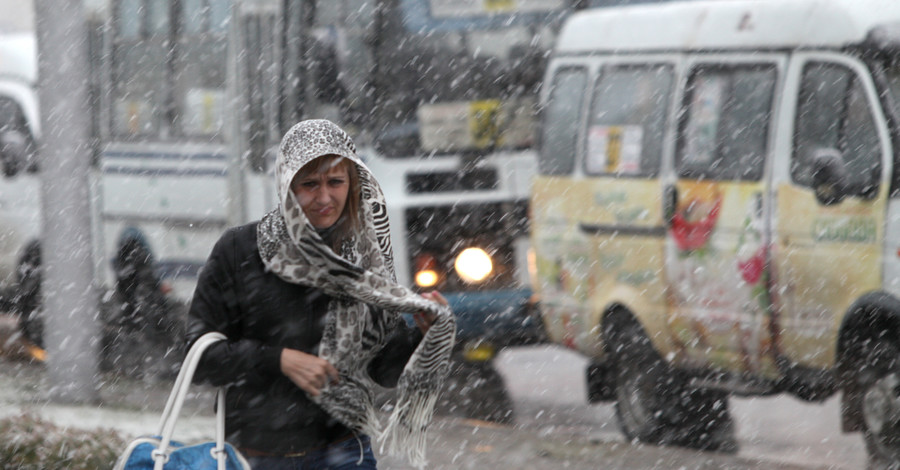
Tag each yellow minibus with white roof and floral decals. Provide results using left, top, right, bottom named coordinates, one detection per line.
left=530, top=0, right=900, bottom=462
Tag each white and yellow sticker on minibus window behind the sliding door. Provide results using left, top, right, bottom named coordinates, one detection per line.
left=586, top=126, right=644, bottom=175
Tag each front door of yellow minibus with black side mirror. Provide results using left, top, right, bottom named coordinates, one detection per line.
left=772, top=52, right=891, bottom=369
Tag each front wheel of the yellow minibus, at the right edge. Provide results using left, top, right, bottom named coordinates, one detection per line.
left=858, top=339, right=900, bottom=462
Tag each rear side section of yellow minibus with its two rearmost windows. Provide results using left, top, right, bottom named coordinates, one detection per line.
left=531, top=58, right=675, bottom=355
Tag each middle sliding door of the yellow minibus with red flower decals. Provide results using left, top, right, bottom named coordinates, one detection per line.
left=666, top=59, right=784, bottom=372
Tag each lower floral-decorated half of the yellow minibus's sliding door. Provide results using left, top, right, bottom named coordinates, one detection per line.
left=666, top=181, right=771, bottom=371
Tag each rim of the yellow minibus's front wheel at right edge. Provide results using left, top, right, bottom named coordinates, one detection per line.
left=862, top=373, right=900, bottom=460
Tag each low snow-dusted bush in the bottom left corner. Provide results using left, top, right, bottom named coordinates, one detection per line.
left=0, top=414, right=125, bottom=470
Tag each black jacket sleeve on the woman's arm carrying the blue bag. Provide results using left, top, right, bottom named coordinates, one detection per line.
left=186, top=229, right=281, bottom=386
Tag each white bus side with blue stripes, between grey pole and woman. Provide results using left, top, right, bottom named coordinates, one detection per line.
left=92, top=0, right=281, bottom=302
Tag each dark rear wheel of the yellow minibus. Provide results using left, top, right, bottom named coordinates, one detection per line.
left=604, top=313, right=737, bottom=452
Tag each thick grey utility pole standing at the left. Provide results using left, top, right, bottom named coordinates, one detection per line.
left=34, top=0, right=99, bottom=403
